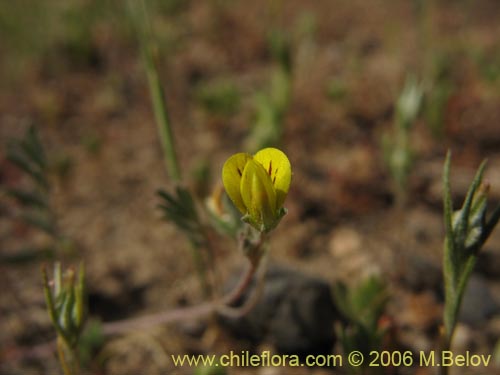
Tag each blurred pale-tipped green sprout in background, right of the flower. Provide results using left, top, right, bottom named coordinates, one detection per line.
left=382, top=77, right=423, bottom=206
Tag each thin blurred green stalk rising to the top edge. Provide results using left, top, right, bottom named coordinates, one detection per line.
left=129, top=0, right=181, bottom=182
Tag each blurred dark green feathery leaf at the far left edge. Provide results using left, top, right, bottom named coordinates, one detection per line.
left=1, top=125, right=73, bottom=263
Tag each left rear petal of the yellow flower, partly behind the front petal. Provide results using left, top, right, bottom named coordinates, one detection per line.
left=222, top=152, right=252, bottom=214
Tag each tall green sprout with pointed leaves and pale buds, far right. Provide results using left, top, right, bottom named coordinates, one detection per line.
left=441, top=152, right=500, bottom=374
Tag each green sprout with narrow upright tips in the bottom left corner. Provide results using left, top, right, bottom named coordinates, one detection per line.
left=42, top=262, right=87, bottom=375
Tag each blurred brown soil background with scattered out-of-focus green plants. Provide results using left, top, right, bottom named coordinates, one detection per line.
left=0, top=0, right=500, bottom=374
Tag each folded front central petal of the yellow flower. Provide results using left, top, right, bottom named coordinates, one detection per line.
left=241, top=159, right=276, bottom=228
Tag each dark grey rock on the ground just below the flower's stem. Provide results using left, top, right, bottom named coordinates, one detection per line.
left=220, top=266, right=337, bottom=356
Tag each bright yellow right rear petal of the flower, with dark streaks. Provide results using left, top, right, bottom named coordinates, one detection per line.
left=254, top=147, right=292, bottom=209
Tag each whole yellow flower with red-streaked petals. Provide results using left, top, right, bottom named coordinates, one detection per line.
left=222, top=148, right=292, bottom=232
